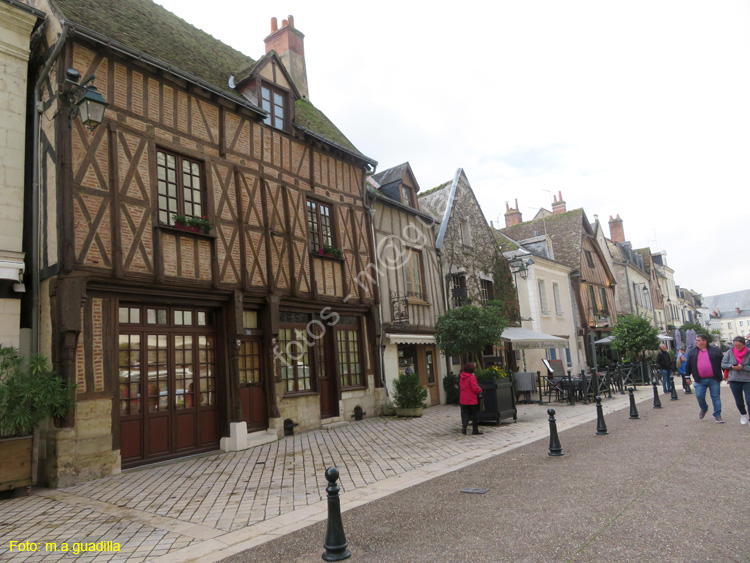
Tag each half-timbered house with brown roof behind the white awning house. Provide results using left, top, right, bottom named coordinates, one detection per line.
left=501, top=194, right=617, bottom=366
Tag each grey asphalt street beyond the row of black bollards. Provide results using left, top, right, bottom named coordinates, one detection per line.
left=223, top=386, right=750, bottom=563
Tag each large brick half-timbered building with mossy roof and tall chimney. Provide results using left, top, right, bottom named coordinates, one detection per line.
left=27, top=0, right=382, bottom=486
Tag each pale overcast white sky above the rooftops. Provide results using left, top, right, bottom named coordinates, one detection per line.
left=159, top=0, right=750, bottom=295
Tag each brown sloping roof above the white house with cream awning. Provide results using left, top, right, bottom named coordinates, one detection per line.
left=500, top=209, right=585, bottom=270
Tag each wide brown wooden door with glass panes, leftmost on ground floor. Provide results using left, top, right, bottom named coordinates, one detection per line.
left=118, top=307, right=219, bottom=467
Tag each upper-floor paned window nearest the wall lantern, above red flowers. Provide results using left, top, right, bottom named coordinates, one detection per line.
left=156, top=150, right=204, bottom=229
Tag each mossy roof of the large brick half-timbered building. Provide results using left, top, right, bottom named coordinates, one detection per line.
left=51, top=0, right=377, bottom=164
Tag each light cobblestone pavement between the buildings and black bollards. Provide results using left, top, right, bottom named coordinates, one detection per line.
left=0, top=389, right=656, bottom=563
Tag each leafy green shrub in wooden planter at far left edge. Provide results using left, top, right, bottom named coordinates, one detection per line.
left=0, top=346, right=75, bottom=491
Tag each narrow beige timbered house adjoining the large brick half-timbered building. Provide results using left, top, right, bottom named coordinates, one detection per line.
left=368, top=162, right=445, bottom=405
